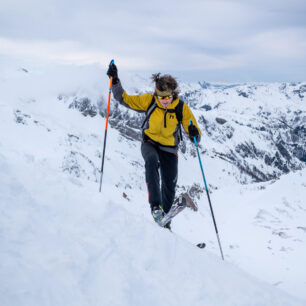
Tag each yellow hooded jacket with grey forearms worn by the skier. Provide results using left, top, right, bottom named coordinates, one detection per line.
left=113, top=82, right=201, bottom=147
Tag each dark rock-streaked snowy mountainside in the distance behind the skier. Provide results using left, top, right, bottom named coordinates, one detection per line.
left=58, top=83, right=306, bottom=183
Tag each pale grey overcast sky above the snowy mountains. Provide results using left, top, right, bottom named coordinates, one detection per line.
left=0, top=0, right=306, bottom=82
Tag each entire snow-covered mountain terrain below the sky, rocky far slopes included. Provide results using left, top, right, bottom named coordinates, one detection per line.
left=0, top=62, right=306, bottom=305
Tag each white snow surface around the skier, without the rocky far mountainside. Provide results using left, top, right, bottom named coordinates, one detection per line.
left=0, top=63, right=306, bottom=305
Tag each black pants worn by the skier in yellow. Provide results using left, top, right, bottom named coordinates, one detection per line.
left=141, top=141, right=178, bottom=213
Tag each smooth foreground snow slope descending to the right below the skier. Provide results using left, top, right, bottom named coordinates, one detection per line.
left=0, top=156, right=302, bottom=306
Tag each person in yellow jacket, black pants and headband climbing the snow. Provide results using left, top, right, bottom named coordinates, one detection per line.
left=107, top=62, right=201, bottom=229
